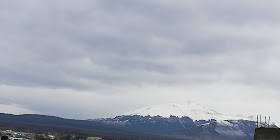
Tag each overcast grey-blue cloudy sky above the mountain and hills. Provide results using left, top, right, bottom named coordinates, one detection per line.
left=0, top=0, right=280, bottom=119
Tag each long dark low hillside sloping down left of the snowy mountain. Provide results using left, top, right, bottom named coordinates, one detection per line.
left=0, top=113, right=187, bottom=140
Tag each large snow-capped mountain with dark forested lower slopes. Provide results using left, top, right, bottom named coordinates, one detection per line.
left=94, top=101, right=276, bottom=140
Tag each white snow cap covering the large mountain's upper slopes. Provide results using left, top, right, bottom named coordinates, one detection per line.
left=125, top=101, right=249, bottom=121
